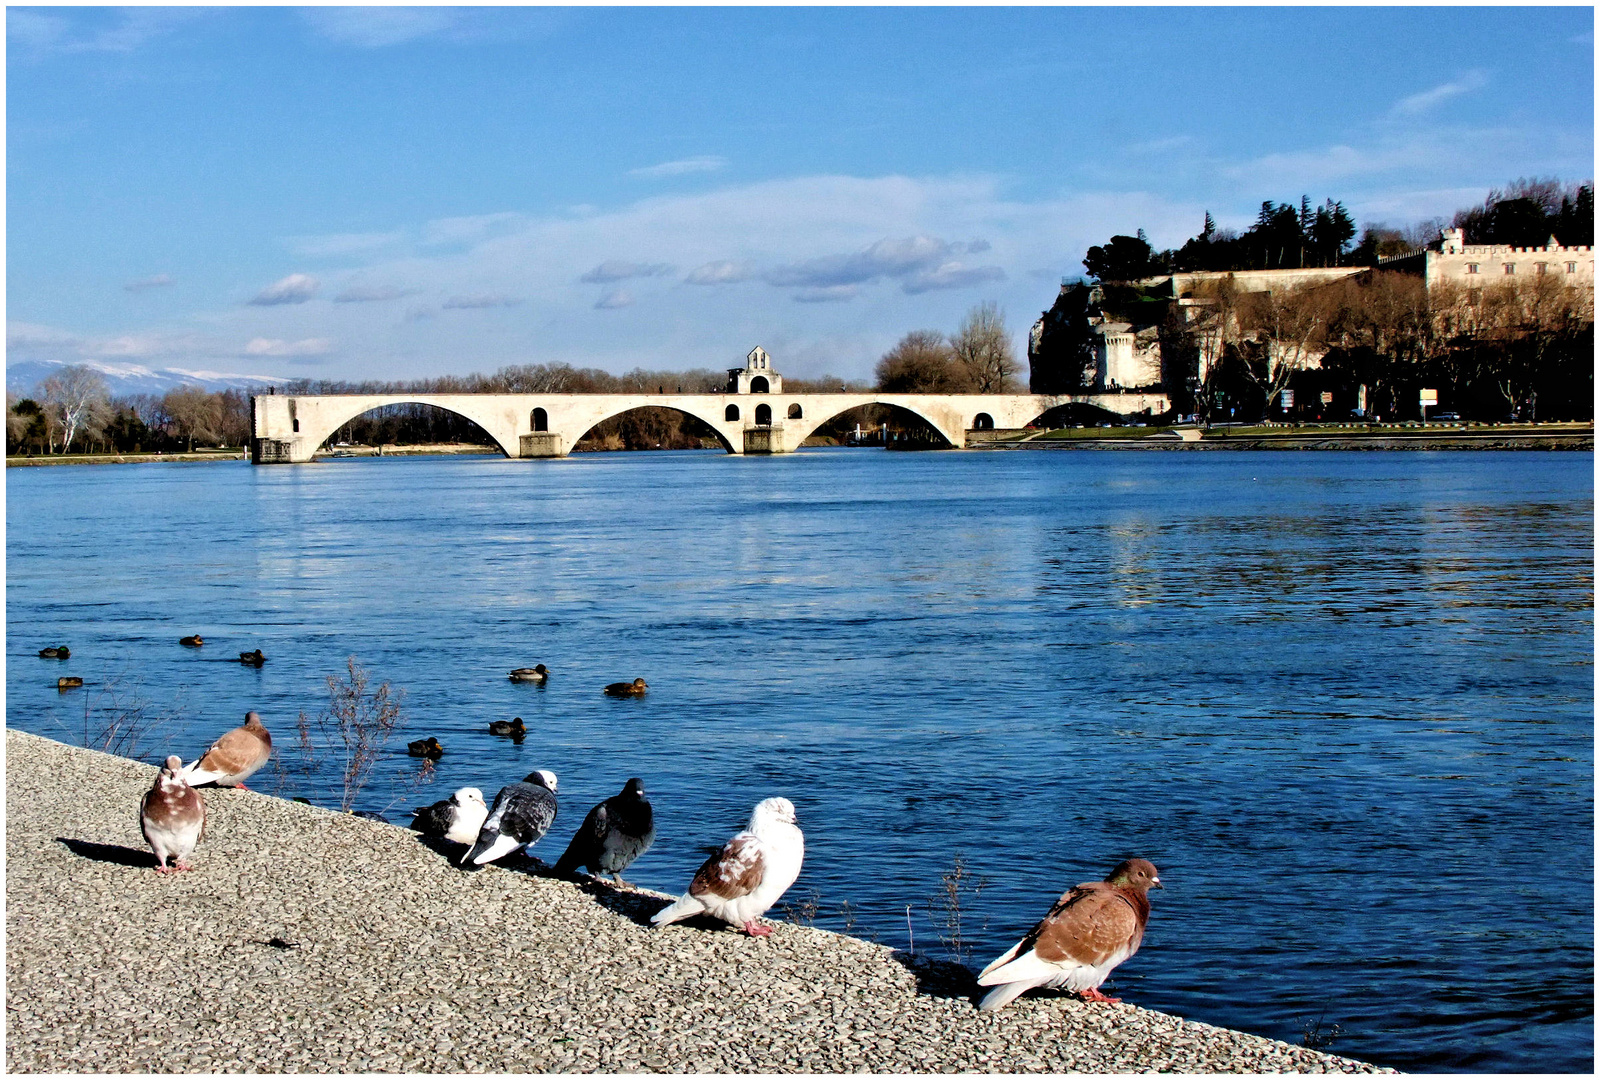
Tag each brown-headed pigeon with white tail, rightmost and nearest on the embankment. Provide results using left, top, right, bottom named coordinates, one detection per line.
left=978, top=859, right=1162, bottom=1013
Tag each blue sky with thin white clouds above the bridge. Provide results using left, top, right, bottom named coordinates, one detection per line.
left=6, top=6, right=1595, bottom=388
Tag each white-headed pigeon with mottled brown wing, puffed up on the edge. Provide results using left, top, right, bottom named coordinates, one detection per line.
left=650, top=798, right=805, bottom=938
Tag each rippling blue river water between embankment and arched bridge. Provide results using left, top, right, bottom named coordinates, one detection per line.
left=6, top=450, right=1594, bottom=1072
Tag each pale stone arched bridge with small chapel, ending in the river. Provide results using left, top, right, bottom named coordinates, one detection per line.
left=250, top=387, right=1171, bottom=466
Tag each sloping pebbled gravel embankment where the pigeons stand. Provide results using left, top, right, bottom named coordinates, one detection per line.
left=5, top=731, right=1373, bottom=1072
